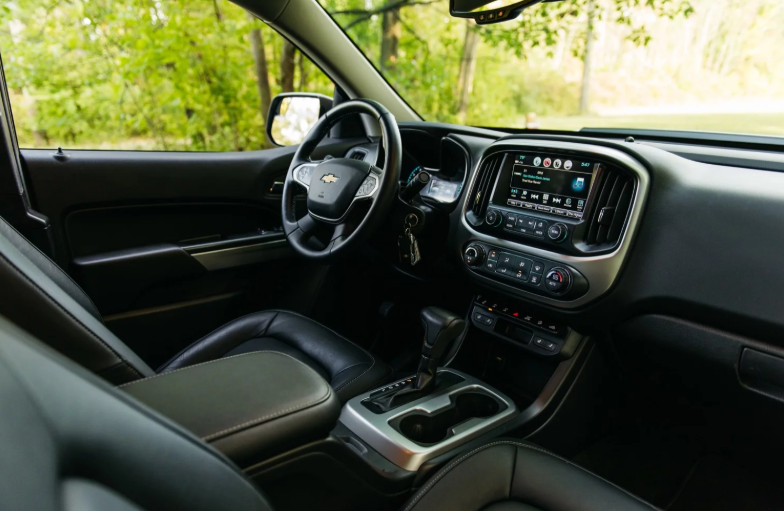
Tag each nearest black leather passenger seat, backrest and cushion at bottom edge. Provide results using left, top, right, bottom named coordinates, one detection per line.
left=0, top=317, right=656, bottom=511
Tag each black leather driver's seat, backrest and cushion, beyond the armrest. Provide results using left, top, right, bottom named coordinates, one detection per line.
left=0, top=219, right=392, bottom=402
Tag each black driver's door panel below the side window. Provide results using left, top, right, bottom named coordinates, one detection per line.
left=21, top=138, right=367, bottom=367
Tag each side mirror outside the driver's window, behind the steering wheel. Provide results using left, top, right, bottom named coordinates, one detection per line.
left=267, top=92, right=332, bottom=146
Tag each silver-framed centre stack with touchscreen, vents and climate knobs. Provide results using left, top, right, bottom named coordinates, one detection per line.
left=458, top=138, right=649, bottom=308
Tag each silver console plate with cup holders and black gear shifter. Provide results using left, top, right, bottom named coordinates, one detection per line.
left=340, top=307, right=517, bottom=471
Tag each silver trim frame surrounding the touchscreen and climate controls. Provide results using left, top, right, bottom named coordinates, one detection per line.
left=460, top=140, right=650, bottom=309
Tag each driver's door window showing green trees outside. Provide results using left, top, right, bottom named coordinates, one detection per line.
left=0, top=0, right=333, bottom=151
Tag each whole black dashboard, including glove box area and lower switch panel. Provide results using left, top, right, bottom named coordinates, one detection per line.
left=340, top=122, right=784, bottom=424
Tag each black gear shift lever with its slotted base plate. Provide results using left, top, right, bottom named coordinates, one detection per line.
left=373, top=307, right=465, bottom=413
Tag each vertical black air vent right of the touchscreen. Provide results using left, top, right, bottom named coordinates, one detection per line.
left=585, top=167, right=634, bottom=248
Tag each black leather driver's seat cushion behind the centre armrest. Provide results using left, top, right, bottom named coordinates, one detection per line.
left=158, top=310, right=392, bottom=403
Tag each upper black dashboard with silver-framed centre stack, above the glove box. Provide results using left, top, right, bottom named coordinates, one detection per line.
left=346, top=122, right=784, bottom=343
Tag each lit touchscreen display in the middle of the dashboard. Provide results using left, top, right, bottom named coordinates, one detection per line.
left=491, top=154, right=595, bottom=218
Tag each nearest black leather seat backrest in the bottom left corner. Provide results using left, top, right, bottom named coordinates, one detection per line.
left=0, top=317, right=271, bottom=511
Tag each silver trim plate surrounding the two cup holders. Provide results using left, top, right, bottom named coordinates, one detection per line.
left=340, top=368, right=518, bottom=471
